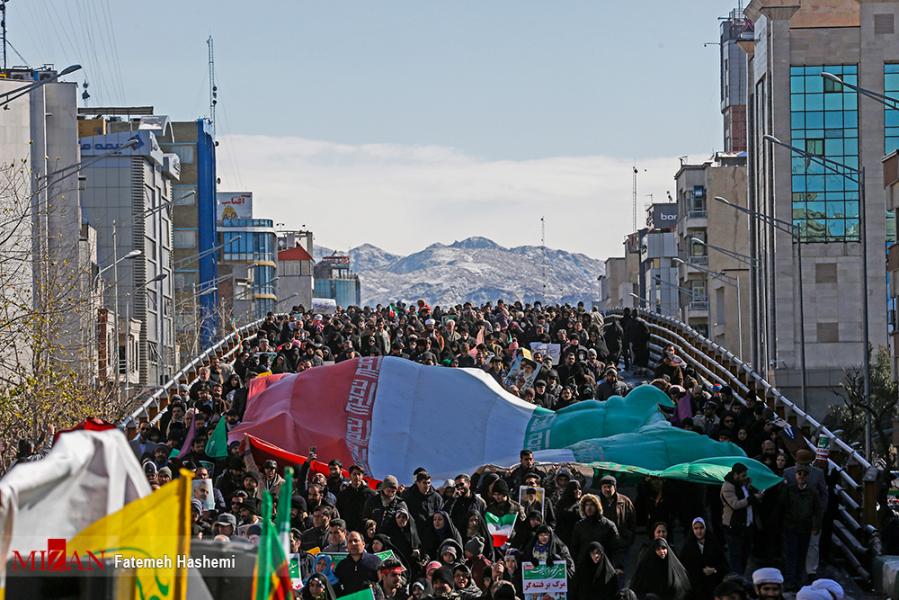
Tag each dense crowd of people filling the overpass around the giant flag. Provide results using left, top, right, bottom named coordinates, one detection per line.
left=123, top=301, right=856, bottom=600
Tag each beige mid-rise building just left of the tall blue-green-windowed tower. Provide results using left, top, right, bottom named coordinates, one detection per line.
left=674, top=152, right=756, bottom=364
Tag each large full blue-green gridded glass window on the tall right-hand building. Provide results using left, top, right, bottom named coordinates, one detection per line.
left=790, top=65, right=860, bottom=242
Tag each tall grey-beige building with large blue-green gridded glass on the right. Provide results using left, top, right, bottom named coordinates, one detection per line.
left=740, top=0, right=899, bottom=412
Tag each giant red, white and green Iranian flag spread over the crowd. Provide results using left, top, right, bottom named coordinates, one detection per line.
left=228, top=356, right=778, bottom=485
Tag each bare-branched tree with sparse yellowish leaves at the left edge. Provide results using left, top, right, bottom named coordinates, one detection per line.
left=0, top=160, right=130, bottom=470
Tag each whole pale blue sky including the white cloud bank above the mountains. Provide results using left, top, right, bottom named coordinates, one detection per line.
left=14, top=0, right=733, bottom=257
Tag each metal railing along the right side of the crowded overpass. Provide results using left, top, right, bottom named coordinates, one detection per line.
left=608, top=310, right=880, bottom=581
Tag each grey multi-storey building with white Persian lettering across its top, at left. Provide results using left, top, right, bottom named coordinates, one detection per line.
left=80, top=120, right=180, bottom=386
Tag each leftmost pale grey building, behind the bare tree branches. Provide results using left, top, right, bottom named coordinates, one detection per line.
left=0, top=66, right=98, bottom=380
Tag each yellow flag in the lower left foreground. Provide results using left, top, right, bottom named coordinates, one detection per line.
left=66, top=469, right=193, bottom=600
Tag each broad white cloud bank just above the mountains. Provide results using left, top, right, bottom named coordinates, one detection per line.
left=218, top=135, right=704, bottom=258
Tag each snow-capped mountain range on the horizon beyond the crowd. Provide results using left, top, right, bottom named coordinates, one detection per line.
left=314, top=237, right=604, bottom=306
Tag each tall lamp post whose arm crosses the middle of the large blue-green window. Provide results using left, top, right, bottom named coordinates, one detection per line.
left=764, top=131, right=871, bottom=459
